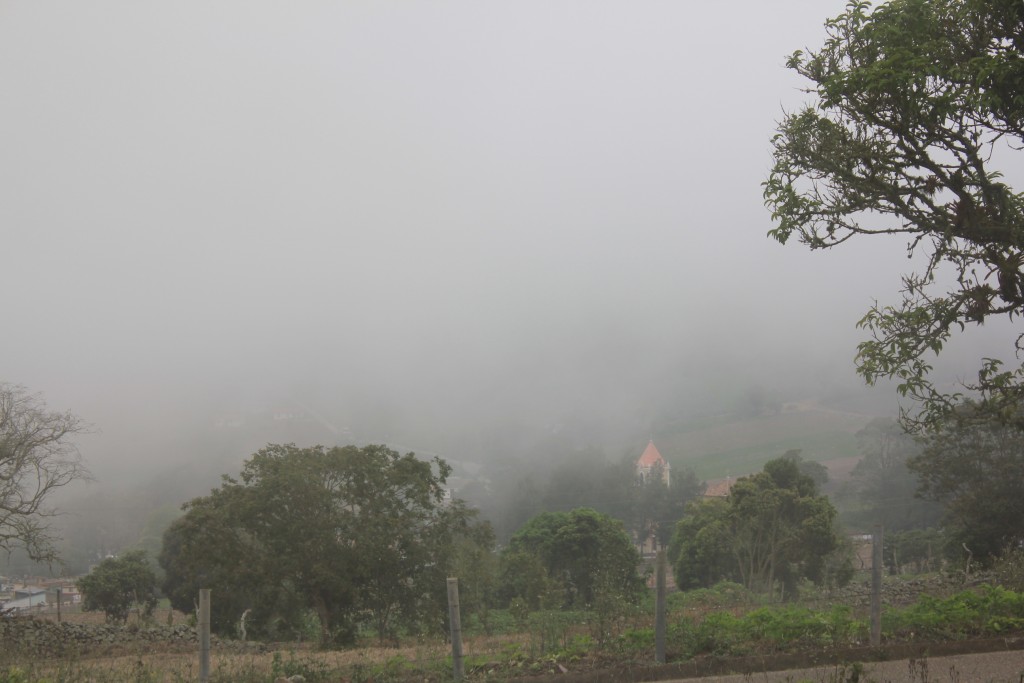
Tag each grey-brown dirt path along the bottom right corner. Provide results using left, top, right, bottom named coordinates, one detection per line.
left=668, top=650, right=1024, bottom=683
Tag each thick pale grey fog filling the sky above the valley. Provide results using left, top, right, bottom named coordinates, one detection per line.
left=0, top=0, right=1003, bottom=491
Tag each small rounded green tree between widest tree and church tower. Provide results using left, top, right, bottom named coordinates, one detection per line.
left=503, top=508, right=643, bottom=607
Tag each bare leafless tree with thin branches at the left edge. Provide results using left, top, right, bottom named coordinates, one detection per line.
left=0, top=383, right=89, bottom=562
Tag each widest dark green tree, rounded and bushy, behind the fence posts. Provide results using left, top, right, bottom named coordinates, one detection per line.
left=160, top=444, right=473, bottom=644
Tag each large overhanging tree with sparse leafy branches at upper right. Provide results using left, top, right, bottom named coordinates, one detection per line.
left=764, top=0, right=1024, bottom=431
